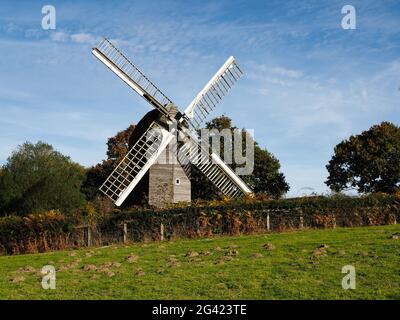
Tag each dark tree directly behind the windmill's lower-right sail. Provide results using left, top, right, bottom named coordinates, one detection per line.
left=191, top=116, right=289, bottom=199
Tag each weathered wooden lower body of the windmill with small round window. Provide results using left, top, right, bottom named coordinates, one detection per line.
left=148, top=148, right=191, bottom=208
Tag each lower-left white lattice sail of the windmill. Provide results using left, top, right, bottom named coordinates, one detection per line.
left=100, top=122, right=175, bottom=206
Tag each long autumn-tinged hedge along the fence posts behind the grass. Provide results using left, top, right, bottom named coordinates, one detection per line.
left=0, top=194, right=400, bottom=254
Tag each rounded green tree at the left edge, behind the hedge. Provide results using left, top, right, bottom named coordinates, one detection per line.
left=0, top=142, right=85, bottom=215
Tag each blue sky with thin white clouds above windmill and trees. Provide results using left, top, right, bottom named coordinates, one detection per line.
left=0, top=0, right=400, bottom=196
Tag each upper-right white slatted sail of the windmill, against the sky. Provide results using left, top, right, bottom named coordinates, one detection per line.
left=185, top=56, right=243, bottom=132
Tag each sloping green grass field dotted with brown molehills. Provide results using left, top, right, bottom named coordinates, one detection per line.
left=0, top=225, right=400, bottom=299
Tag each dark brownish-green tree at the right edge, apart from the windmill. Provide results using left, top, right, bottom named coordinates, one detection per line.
left=325, top=122, right=400, bottom=193
